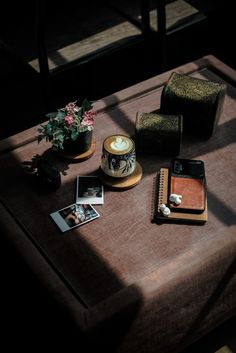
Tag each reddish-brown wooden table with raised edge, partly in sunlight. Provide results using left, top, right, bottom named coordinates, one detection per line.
left=0, top=56, right=236, bottom=353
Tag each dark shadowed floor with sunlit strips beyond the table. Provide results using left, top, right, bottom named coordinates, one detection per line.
left=0, top=0, right=236, bottom=138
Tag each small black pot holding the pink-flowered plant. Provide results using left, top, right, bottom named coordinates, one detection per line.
left=63, top=130, right=93, bottom=154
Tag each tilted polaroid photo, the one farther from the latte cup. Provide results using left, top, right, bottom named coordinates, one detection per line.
left=50, top=204, right=100, bottom=232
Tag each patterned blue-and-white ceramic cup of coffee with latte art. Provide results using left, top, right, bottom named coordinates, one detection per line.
left=101, top=135, right=136, bottom=178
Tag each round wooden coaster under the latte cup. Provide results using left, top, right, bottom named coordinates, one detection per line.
left=100, top=162, right=142, bottom=190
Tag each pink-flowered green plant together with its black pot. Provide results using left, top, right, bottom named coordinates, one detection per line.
left=38, top=99, right=96, bottom=154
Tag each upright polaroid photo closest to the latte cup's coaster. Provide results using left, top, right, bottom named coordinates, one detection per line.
left=75, top=175, right=104, bottom=205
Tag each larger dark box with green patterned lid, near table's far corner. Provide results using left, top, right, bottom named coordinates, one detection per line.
left=160, top=72, right=226, bottom=138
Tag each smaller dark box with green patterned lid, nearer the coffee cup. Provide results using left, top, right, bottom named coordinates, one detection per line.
left=135, top=112, right=182, bottom=156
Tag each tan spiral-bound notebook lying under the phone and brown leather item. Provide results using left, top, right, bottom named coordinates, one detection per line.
left=154, top=168, right=208, bottom=223
